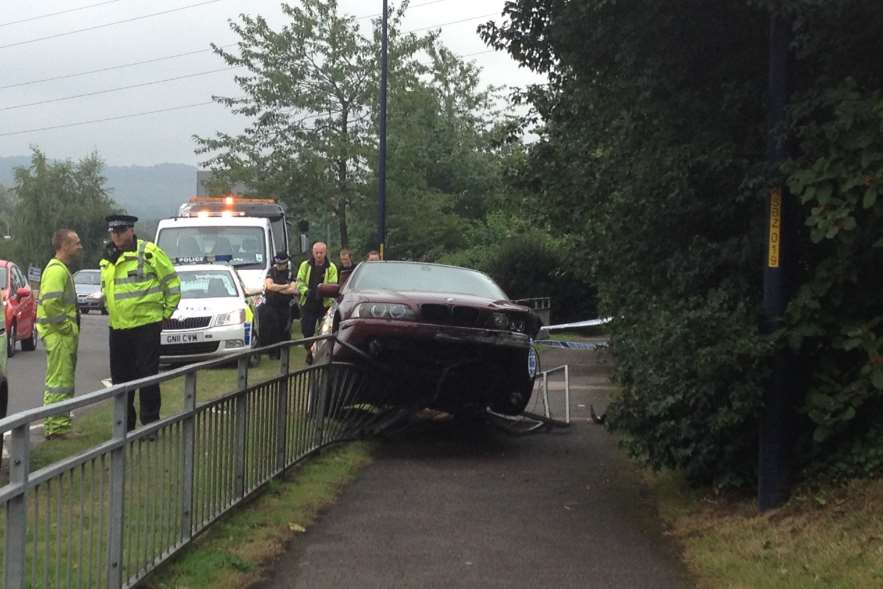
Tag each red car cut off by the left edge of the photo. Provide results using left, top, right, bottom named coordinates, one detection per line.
left=0, top=260, right=37, bottom=357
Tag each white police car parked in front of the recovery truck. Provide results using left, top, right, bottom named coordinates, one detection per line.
left=159, top=264, right=257, bottom=364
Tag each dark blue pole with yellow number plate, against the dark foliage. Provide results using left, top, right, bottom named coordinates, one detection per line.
left=757, top=15, right=800, bottom=511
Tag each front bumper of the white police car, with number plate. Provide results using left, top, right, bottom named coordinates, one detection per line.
left=159, top=323, right=252, bottom=363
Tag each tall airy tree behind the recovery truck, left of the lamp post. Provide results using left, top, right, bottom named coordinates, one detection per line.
left=196, top=0, right=388, bottom=245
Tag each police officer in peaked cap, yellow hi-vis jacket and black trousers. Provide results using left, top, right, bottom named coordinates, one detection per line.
left=100, top=215, right=181, bottom=430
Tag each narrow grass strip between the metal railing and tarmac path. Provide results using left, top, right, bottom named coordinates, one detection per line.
left=143, top=442, right=373, bottom=589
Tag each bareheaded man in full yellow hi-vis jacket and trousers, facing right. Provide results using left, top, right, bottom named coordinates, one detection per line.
left=37, top=229, right=83, bottom=438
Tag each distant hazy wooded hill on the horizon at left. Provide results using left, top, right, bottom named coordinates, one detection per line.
left=0, top=156, right=197, bottom=220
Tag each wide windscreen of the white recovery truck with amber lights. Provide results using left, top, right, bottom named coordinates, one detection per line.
left=156, top=227, right=270, bottom=268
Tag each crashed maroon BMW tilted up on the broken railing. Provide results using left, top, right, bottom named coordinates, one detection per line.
left=316, top=262, right=540, bottom=415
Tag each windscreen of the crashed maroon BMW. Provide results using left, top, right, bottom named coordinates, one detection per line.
left=347, top=262, right=508, bottom=301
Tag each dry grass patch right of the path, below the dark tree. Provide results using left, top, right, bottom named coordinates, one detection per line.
left=653, top=474, right=883, bottom=589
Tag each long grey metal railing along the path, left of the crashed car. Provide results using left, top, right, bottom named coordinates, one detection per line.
left=0, top=336, right=382, bottom=589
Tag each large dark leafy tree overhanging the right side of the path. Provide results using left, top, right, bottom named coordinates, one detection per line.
left=483, top=0, right=883, bottom=485
